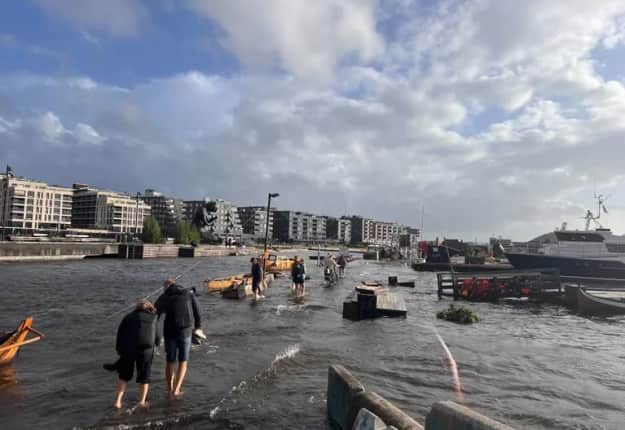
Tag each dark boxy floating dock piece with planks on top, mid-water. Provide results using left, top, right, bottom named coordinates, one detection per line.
left=343, top=283, right=408, bottom=321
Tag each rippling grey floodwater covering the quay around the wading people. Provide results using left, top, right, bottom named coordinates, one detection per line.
left=0, top=257, right=625, bottom=429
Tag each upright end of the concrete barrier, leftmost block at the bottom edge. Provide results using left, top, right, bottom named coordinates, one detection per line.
left=327, top=364, right=365, bottom=430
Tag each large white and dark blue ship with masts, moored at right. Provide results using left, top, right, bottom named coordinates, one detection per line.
left=505, top=195, right=625, bottom=282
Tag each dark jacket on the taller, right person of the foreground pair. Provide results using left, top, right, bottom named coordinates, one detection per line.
left=155, top=284, right=202, bottom=338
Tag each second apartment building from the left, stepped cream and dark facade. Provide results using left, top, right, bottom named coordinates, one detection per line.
left=72, top=184, right=150, bottom=234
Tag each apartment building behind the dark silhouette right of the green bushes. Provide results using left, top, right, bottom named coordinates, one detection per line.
left=184, top=198, right=243, bottom=240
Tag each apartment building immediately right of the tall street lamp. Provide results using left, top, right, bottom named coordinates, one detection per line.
left=273, top=210, right=326, bottom=242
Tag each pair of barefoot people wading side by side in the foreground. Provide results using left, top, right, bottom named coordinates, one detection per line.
left=104, top=279, right=204, bottom=409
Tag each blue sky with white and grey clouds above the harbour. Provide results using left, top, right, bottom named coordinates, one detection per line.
left=0, top=0, right=625, bottom=240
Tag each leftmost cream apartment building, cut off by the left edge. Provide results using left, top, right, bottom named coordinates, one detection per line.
left=0, top=174, right=73, bottom=231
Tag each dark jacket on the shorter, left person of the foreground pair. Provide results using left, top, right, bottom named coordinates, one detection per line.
left=115, top=309, right=159, bottom=356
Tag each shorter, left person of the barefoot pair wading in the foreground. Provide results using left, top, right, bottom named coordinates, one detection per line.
left=112, top=300, right=159, bottom=409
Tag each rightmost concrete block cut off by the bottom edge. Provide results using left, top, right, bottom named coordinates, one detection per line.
left=425, top=401, right=513, bottom=430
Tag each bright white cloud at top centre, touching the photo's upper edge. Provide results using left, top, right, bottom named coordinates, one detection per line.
left=188, top=0, right=384, bottom=79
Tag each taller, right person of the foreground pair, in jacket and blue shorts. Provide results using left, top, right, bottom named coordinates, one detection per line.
left=156, top=279, right=202, bottom=397
